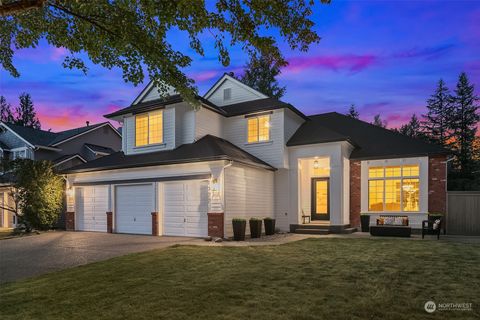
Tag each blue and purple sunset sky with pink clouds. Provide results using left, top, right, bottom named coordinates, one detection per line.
left=0, top=0, right=480, bottom=130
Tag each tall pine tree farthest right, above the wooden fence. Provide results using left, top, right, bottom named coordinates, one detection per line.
left=450, top=72, right=480, bottom=176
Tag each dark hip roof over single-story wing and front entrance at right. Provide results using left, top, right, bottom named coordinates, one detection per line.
left=287, top=112, right=449, bottom=160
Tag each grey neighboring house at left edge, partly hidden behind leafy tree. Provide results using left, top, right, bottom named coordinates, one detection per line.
left=0, top=122, right=122, bottom=227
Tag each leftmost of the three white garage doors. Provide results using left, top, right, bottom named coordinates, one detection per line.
left=75, top=186, right=108, bottom=232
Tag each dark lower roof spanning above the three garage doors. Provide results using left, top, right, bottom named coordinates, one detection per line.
left=63, top=135, right=276, bottom=173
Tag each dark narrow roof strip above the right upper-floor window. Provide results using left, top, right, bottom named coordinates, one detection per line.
left=219, top=98, right=307, bottom=119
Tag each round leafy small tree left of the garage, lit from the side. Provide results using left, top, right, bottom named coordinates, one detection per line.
left=0, top=159, right=64, bottom=231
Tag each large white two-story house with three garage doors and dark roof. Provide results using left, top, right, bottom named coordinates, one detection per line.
left=65, top=75, right=446, bottom=236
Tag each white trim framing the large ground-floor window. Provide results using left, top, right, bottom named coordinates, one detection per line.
left=360, top=157, right=428, bottom=215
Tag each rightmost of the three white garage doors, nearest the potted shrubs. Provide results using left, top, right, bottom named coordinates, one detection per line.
left=164, top=181, right=208, bottom=237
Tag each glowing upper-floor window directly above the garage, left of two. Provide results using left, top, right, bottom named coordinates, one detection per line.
left=135, top=110, right=163, bottom=147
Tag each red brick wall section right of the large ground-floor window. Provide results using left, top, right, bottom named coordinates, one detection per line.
left=428, top=155, right=447, bottom=214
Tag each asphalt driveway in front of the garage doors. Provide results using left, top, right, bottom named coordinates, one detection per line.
left=0, top=232, right=199, bottom=284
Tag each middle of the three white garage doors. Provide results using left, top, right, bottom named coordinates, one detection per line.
left=115, top=184, right=155, bottom=234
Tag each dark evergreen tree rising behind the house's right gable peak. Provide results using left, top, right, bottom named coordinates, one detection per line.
left=240, top=53, right=286, bottom=99
